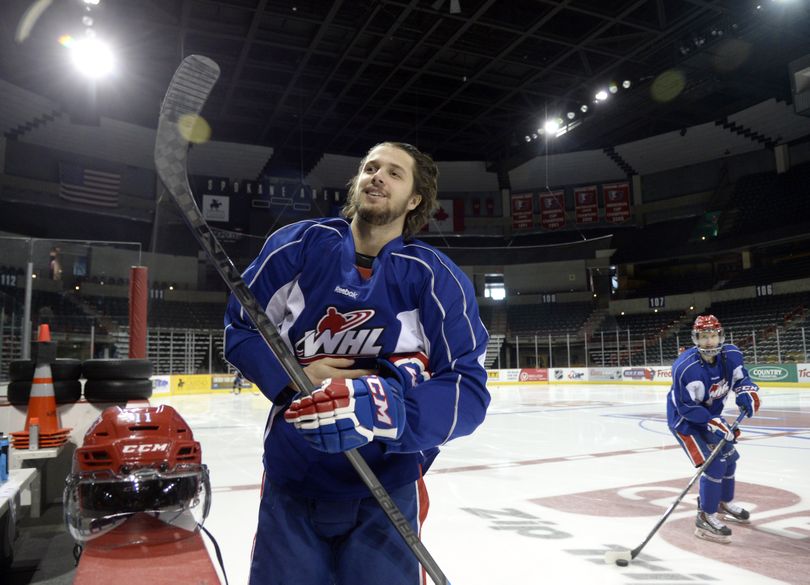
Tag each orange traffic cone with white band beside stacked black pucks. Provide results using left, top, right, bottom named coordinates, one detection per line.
left=11, top=324, right=71, bottom=449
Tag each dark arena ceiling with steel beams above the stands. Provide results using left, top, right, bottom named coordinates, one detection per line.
left=0, top=0, right=810, bottom=176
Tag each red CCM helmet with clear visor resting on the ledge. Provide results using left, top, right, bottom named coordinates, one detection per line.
left=64, top=406, right=211, bottom=547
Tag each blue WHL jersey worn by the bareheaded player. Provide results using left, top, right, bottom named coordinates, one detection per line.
left=225, top=218, right=490, bottom=499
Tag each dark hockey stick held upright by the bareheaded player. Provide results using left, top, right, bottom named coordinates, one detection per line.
left=155, top=55, right=449, bottom=585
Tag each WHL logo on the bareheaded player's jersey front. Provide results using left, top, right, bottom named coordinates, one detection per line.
left=295, top=307, right=383, bottom=364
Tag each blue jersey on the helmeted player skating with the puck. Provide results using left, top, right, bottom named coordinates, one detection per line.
left=667, top=343, right=758, bottom=435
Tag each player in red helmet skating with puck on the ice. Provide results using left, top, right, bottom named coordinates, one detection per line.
left=667, top=315, right=760, bottom=543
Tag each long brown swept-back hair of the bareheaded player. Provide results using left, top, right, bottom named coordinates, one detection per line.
left=341, top=142, right=439, bottom=240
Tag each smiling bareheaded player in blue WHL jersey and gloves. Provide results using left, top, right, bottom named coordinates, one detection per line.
left=225, top=142, right=490, bottom=585
